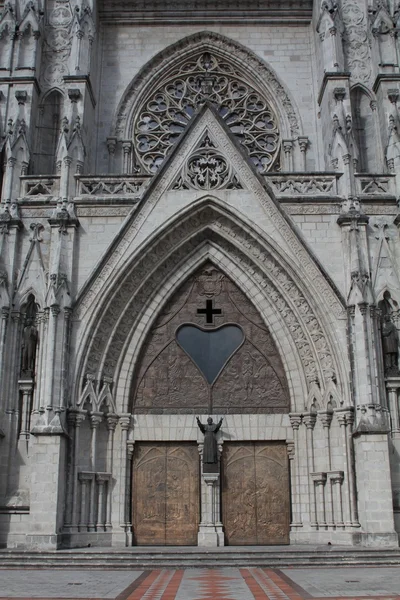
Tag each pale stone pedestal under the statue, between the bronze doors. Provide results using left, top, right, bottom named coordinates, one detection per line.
left=197, top=473, right=224, bottom=547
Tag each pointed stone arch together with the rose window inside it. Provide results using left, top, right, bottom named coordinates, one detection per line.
left=109, top=32, right=301, bottom=175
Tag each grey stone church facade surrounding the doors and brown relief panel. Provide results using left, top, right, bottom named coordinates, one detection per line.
left=0, top=0, right=400, bottom=548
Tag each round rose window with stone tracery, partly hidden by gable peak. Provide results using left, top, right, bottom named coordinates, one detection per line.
left=134, top=53, right=280, bottom=173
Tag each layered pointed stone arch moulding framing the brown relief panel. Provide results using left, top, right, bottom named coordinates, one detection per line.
left=74, top=197, right=347, bottom=411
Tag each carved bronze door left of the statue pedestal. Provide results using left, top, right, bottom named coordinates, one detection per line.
left=132, top=442, right=199, bottom=546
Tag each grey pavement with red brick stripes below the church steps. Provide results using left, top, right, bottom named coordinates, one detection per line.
left=0, top=567, right=400, bottom=600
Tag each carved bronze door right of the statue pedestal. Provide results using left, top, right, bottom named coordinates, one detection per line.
left=222, top=442, right=290, bottom=546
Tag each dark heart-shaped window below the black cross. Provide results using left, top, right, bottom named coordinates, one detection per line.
left=176, top=325, right=244, bottom=385
